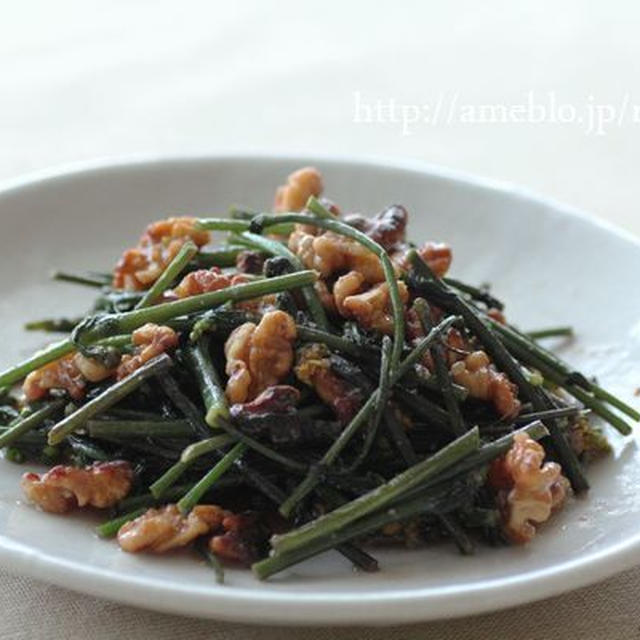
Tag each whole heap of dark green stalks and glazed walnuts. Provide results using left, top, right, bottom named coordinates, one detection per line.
left=0, top=167, right=640, bottom=579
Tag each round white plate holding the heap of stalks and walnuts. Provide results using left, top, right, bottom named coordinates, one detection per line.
left=0, top=157, right=640, bottom=624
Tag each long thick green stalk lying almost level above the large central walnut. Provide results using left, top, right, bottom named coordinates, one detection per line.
left=72, top=271, right=316, bottom=348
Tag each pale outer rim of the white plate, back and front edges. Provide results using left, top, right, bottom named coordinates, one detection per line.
left=0, top=151, right=640, bottom=626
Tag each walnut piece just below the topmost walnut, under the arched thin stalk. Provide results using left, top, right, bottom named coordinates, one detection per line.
left=289, top=229, right=384, bottom=284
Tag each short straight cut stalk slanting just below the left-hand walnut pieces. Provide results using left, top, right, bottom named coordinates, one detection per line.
left=48, top=353, right=171, bottom=444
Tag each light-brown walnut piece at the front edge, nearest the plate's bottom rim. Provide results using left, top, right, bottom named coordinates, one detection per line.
left=118, top=504, right=230, bottom=553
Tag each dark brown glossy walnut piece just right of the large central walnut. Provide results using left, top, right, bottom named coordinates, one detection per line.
left=295, top=343, right=362, bottom=424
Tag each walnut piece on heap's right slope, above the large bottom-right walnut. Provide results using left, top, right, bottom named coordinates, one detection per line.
left=451, top=351, right=520, bottom=418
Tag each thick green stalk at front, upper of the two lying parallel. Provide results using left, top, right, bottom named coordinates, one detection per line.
left=271, top=427, right=480, bottom=553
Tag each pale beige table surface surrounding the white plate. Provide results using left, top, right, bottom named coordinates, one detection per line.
left=0, top=0, right=640, bottom=640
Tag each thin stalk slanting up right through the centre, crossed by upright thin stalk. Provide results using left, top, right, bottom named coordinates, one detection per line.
left=280, top=316, right=459, bottom=518
